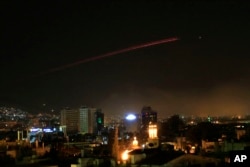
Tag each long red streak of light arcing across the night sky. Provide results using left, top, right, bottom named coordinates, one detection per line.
left=41, top=37, right=179, bottom=74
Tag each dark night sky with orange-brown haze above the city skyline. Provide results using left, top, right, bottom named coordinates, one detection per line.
left=0, top=0, right=250, bottom=117
